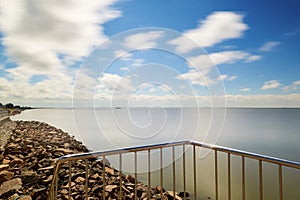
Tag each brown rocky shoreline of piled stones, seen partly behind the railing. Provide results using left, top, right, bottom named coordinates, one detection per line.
left=0, top=120, right=185, bottom=200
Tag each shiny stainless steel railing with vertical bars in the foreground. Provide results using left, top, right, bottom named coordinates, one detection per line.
left=49, top=141, right=300, bottom=200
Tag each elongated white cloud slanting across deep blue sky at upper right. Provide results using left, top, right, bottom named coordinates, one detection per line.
left=169, top=12, right=248, bottom=53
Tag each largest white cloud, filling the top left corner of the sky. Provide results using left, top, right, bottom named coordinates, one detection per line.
left=0, top=0, right=121, bottom=74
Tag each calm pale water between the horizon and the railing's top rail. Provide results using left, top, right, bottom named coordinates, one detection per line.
left=12, top=108, right=300, bottom=162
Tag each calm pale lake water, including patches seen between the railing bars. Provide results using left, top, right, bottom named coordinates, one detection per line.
left=12, top=108, right=300, bottom=199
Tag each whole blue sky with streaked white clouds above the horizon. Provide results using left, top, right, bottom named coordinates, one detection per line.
left=0, top=0, right=300, bottom=107
